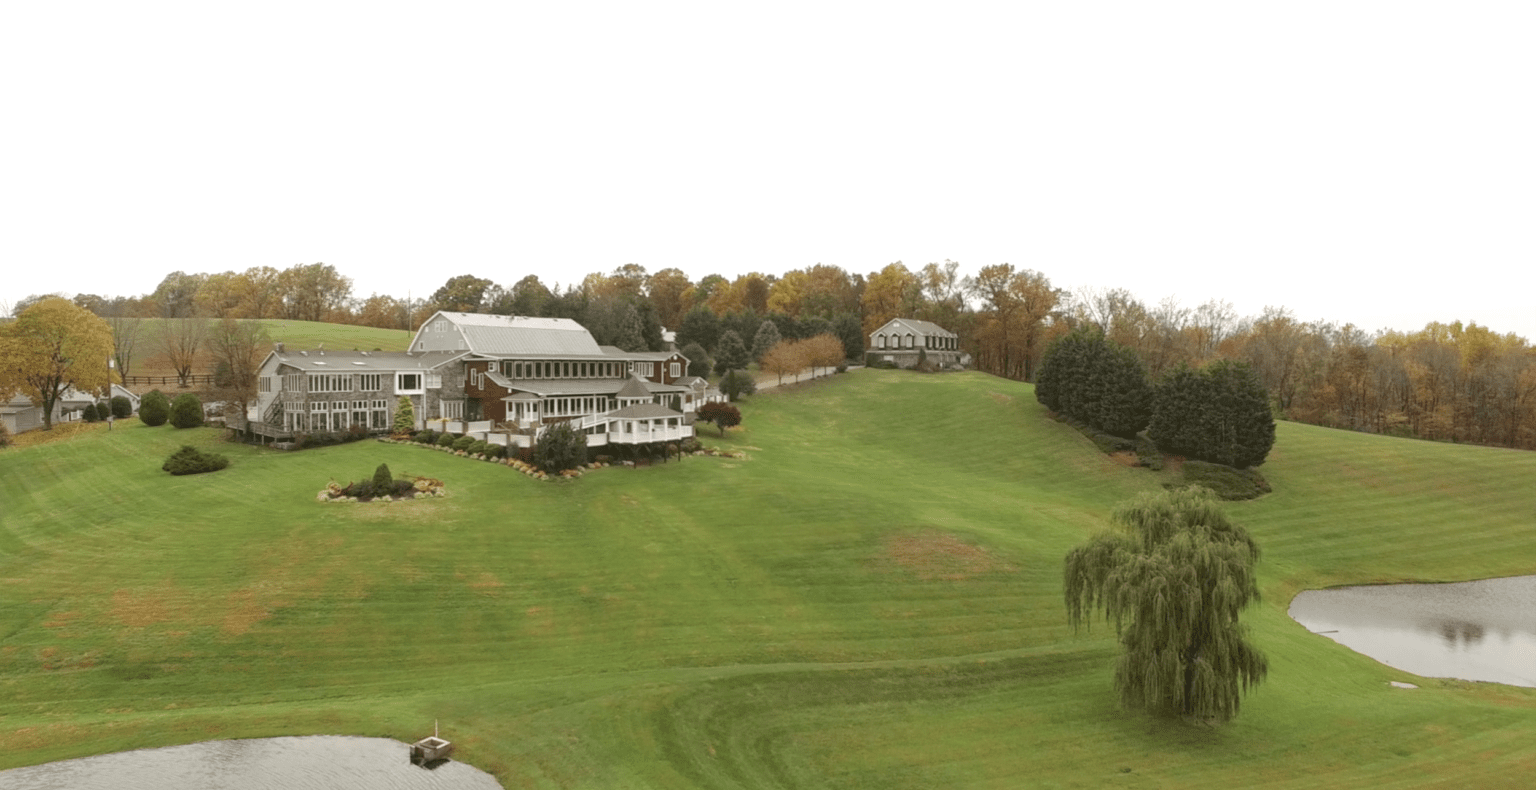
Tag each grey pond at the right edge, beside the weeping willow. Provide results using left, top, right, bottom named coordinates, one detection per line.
left=1290, top=576, right=1536, bottom=687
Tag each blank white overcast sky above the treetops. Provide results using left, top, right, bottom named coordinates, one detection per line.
left=0, top=0, right=1536, bottom=340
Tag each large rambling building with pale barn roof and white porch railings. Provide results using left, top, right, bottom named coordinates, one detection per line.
left=249, top=310, right=720, bottom=447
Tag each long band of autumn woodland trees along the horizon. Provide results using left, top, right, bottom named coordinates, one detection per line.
left=3, top=261, right=1536, bottom=449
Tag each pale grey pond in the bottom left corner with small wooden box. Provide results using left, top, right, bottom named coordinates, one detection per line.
left=0, top=735, right=502, bottom=790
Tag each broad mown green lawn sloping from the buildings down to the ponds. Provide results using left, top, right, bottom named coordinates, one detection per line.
left=0, top=370, right=1536, bottom=788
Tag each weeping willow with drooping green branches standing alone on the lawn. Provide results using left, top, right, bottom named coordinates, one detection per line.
left=1066, top=487, right=1269, bottom=721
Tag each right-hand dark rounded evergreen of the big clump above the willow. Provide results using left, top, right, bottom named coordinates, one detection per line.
left=1147, top=360, right=1275, bottom=469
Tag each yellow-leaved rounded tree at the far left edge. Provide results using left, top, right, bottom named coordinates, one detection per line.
left=0, top=297, right=112, bottom=430
